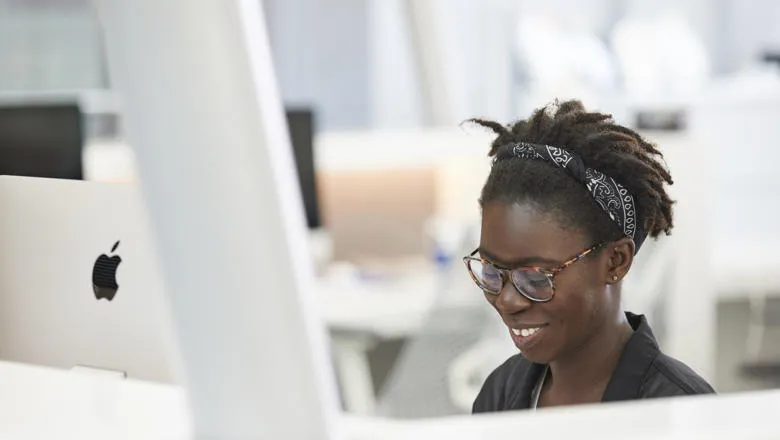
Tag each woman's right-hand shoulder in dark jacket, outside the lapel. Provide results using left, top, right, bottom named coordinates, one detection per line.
left=641, top=351, right=715, bottom=398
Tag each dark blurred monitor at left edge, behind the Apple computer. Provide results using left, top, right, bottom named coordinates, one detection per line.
left=0, top=102, right=84, bottom=180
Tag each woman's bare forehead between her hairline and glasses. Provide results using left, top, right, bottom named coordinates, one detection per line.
left=480, top=202, right=585, bottom=264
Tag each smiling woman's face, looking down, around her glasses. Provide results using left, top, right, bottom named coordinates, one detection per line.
left=479, top=202, right=614, bottom=364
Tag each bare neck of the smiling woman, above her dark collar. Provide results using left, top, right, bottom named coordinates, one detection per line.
left=549, top=308, right=633, bottom=401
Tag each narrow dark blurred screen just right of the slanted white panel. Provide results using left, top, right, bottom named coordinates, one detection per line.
left=286, top=108, right=322, bottom=229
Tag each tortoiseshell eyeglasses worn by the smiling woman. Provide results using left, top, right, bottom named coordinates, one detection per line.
left=463, top=242, right=606, bottom=302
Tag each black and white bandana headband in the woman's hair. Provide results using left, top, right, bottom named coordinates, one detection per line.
left=495, top=142, right=647, bottom=253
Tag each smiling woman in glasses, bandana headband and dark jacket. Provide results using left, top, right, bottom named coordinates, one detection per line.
left=464, top=101, right=714, bottom=412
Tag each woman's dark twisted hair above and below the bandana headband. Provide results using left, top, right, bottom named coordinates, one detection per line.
left=470, top=100, right=674, bottom=248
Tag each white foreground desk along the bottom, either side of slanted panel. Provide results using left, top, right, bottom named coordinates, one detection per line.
left=0, top=362, right=780, bottom=440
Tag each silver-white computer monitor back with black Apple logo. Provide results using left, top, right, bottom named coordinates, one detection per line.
left=0, top=176, right=176, bottom=382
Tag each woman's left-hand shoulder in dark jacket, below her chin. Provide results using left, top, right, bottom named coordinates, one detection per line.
left=472, top=354, right=534, bottom=413
